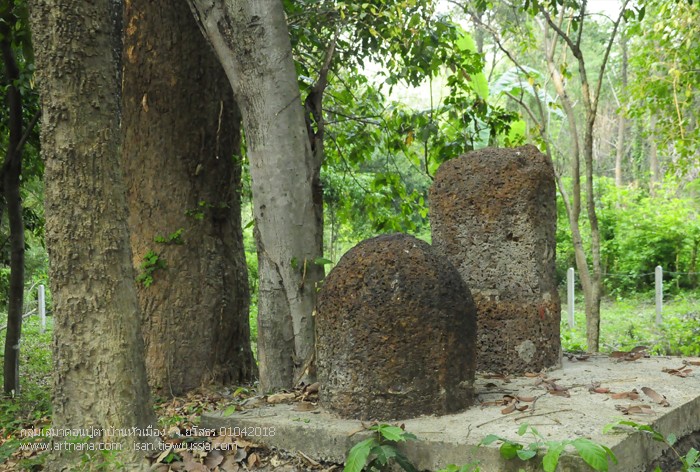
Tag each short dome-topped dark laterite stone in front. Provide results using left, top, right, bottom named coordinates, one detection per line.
left=316, top=234, right=476, bottom=420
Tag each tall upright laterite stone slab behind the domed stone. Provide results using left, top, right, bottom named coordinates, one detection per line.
left=430, top=145, right=561, bottom=373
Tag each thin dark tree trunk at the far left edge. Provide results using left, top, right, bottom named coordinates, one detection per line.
left=0, top=2, right=24, bottom=394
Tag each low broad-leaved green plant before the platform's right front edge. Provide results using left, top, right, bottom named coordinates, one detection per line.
left=480, top=423, right=617, bottom=472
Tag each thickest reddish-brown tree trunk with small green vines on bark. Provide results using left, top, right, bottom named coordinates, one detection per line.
left=123, top=0, right=255, bottom=395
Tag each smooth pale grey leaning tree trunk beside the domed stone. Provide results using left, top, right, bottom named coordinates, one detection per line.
left=190, top=0, right=323, bottom=390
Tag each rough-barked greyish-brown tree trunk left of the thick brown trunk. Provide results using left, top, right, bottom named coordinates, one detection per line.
left=30, top=0, right=155, bottom=470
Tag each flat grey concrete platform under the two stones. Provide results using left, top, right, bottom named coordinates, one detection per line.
left=202, top=356, right=700, bottom=472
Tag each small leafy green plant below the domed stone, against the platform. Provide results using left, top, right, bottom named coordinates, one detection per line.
left=343, top=424, right=416, bottom=472
